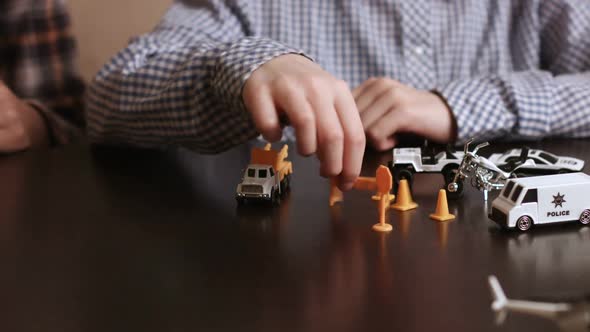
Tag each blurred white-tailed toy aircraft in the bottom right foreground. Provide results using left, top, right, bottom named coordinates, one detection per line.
left=488, top=276, right=590, bottom=332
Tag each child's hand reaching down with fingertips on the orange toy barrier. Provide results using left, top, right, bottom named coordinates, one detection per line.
left=242, top=54, right=365, bottom=190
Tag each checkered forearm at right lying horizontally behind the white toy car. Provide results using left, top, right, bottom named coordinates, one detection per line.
left=437, top=71, right=590, bottom=143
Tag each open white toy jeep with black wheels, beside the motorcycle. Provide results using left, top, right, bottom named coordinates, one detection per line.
left=389, top=147, right=464, bottom=198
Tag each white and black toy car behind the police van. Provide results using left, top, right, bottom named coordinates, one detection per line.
left=488, top=148, right=584, bottom=177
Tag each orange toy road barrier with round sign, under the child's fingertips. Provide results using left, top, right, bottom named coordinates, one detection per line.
left=330, top=165, right=395, bottom=232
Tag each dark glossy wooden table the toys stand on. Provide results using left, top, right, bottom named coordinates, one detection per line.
left=0, top=140, right=590, bottom=332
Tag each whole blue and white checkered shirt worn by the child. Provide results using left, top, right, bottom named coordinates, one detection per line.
left=87, top=0, right=590, bottom=152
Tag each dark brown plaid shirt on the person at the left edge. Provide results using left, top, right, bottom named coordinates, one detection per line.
left=0, top=0, right=84, bottom=144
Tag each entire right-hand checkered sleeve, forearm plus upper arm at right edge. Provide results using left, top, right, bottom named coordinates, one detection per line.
left=436, top=1, right=590, bottom=143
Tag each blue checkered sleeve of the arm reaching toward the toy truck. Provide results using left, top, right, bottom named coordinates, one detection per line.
left=87, top=1, right=310, bottom=153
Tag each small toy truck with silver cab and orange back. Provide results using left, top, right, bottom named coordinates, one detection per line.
left=236, top=144, right=293, bottom=205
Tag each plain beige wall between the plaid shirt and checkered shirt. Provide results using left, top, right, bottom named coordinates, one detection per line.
left=68, top=0, right=172, bottom=81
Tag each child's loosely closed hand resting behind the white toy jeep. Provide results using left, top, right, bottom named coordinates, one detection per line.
left=353, top=78, right=456, bottom=150
